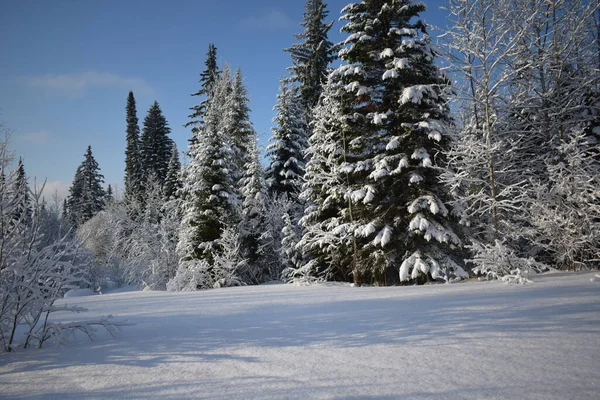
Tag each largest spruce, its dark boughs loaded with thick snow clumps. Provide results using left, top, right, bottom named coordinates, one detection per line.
left=333, top=0, right=464, bottom=284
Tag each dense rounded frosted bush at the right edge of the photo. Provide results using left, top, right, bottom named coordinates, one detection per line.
left=531, top=129, right=600, bottom=270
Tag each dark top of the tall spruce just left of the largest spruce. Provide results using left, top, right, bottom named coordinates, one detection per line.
left=285, top=0, right=335, bottom=111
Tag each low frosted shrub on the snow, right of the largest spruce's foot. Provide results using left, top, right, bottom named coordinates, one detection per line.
left=466, top=240, right=549, bottom=283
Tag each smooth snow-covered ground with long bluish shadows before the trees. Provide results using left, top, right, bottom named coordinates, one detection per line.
left=0, top=273, right=600, bottom=400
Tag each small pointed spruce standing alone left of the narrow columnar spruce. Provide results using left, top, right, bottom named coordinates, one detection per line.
left=67, top=146, right=106, bottom=226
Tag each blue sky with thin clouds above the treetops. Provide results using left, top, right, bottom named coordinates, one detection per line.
left=0, top=0, right=445, bottom=200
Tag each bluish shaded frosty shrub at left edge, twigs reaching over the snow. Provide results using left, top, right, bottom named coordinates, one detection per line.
left=0, top=141, right=124, bottom=351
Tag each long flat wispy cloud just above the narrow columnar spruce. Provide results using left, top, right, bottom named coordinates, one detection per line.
left=25, top=71, right=152, bottom=97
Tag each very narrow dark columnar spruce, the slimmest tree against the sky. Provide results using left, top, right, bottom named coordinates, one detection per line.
left=124, top=92, right=144, bottom=218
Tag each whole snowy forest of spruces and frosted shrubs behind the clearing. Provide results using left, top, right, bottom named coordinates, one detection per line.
left=0, top=0, right=600, bottom=351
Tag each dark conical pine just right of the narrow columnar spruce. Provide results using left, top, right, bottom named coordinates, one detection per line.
left=140, top=101, right=173, bottom=185
